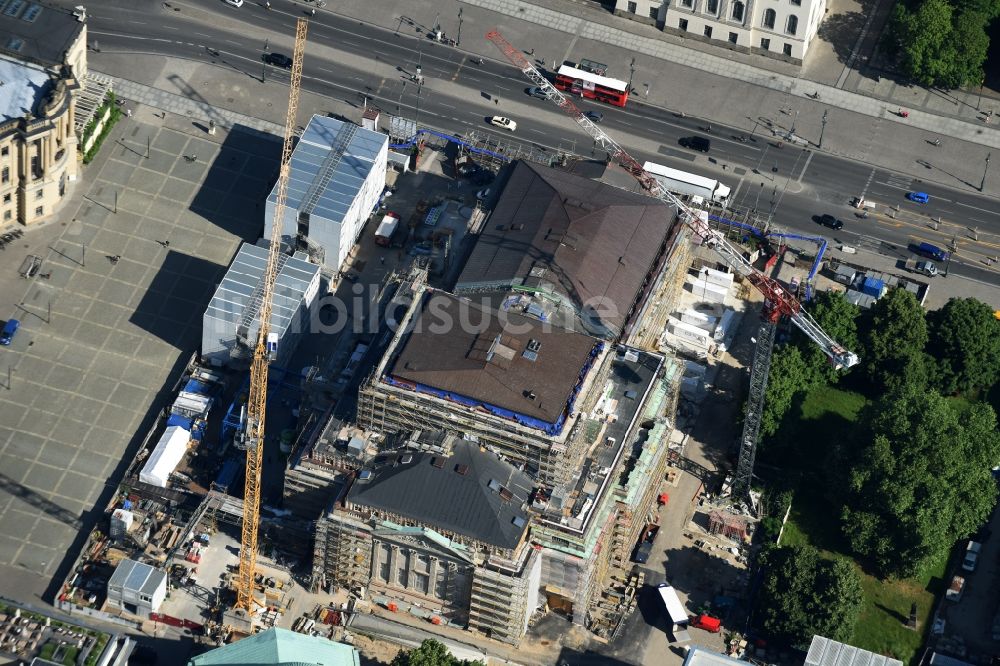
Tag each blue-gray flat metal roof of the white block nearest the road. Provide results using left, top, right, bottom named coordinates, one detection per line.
left=268, top=116, right=389, bottom=220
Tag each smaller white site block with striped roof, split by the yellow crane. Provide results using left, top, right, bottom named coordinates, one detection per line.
left=201, top=243, right=320, bottom=366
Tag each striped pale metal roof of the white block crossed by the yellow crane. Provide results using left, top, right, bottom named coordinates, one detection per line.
left=205, top=243, right=320, bottom=338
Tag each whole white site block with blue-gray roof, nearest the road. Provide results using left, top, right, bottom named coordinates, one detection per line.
left=264, top=116, right=389, bottom=270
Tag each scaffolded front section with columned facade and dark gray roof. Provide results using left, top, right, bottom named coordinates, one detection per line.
left=313, top=440, right=541, bottom=644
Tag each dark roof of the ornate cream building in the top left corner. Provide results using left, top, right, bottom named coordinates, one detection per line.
left=0, top=0, right=84, bottom=68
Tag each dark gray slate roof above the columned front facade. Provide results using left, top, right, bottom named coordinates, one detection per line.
left=347, top=440, right=531, bottom=548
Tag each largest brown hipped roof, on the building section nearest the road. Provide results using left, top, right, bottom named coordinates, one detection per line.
left=455, top=162, right=673, bottom=331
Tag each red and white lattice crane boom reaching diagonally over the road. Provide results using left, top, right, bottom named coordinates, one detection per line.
left=486, top=30, right=858, bottom=368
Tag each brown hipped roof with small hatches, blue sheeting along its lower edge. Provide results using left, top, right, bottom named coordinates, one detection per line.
left=390, top=291, right=598, bottom=423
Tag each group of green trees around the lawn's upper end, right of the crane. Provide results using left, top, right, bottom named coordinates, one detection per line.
left=761, top=289, right=1000, bottom=576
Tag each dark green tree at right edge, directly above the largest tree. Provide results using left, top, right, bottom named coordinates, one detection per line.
left=929, top=298, right=1000, bottom=394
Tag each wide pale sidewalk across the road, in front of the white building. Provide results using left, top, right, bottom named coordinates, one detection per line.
left=296, top=0, right=1000, bottom=195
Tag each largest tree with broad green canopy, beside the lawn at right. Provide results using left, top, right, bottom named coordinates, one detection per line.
left=842, top=387, right=1000, bottom=576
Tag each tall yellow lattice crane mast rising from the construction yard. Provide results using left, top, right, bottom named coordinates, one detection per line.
left=236, top=19, right=309, bottom=615
